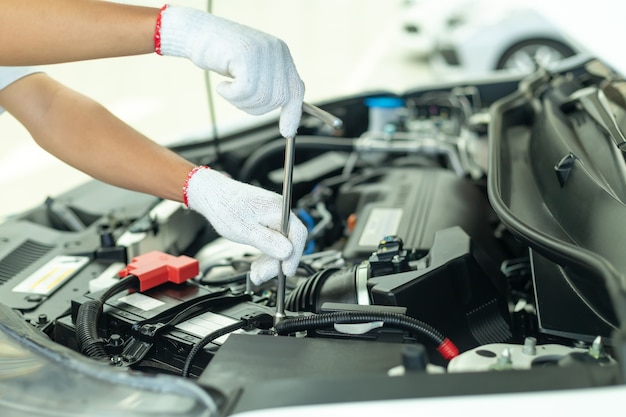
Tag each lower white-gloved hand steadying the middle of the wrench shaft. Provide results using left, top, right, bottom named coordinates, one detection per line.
left=184, top=167, right=307, bottom=285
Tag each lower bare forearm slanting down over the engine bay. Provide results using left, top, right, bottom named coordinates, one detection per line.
left=0, top=73, right=194, bottom=202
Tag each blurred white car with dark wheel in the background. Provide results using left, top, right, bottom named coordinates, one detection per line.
left=431, top=0, right=582, bottom=76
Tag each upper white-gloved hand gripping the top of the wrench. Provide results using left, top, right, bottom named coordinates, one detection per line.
left=155, top=6, right=304, bottom=137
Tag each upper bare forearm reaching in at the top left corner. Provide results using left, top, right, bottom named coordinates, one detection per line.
left=0, top=0, right=159, bottom=66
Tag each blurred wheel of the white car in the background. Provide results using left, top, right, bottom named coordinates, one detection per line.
left=496, top=39, right=576, bottom=72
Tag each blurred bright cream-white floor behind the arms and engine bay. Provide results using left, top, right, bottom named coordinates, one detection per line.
left=0, top=0, right=435, bottom=220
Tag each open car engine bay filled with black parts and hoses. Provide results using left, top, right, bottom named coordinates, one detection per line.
left=0, top=59, right=626, bottom=415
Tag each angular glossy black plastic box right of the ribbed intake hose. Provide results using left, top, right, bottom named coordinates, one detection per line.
left=367, top=227, right=512, bottom=352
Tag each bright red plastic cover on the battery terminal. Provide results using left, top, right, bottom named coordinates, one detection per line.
left=118, top=251, right=200, bottom=291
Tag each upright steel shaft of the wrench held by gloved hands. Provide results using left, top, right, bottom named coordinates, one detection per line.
left=274, top=136, right=296, bottom=324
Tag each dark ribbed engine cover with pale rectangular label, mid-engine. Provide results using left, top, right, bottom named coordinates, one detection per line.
left=337, top=168, right=494, bottom=259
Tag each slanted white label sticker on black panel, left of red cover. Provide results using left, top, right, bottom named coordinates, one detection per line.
left=13, top=255, right=89, bottom=295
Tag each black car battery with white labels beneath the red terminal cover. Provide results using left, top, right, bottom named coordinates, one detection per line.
left=54, top=281, right=273, bottom=375
